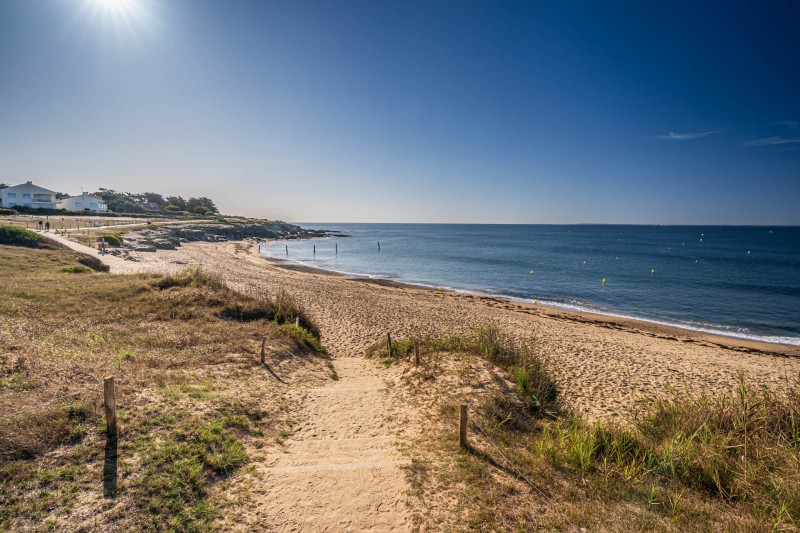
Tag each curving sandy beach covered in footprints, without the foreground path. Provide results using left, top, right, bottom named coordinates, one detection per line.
left=67, top=237, right=800, bottom=420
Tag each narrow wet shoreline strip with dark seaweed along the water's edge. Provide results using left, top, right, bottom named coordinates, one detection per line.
left=256, top=254, right=800, bottom=358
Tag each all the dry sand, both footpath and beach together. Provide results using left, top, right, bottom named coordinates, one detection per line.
left=48, top=236, right=800, bottom=531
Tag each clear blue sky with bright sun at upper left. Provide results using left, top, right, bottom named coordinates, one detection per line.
left=0, top=0, right=800, bottom=225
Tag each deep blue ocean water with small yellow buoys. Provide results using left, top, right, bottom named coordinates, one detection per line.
left=262, top=223, right=800, bottom=345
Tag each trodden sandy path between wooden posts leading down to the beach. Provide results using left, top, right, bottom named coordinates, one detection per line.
left=250, top=358, right=410, bottom=531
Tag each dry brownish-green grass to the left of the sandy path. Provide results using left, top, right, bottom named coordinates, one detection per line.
left=0, top=246, right=330, bottom=531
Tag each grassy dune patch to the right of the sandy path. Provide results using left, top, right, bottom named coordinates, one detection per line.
left=382, top=325, right=800, bottom=531
